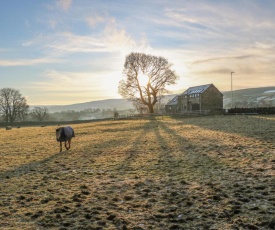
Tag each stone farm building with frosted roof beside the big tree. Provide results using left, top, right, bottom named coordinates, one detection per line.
left=165, top=84, right=223, bottom=113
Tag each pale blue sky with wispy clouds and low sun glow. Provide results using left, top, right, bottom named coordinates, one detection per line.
left=0, top=0, right=275, bottom=105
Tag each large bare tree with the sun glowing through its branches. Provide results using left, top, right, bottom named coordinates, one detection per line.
left=118, top=53, right=178, bottom=113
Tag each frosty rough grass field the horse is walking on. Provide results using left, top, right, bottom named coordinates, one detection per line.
left=0, top=116, right=275, bottom=230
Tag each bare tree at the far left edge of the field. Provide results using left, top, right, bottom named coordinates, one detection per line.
left=0, top=88, right=29, bottom=123
